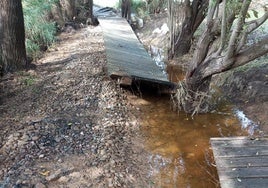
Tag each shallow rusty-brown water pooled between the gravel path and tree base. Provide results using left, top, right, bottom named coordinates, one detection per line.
left=138, top=96, right=248, bottom=188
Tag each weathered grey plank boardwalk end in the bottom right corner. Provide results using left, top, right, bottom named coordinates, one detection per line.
left=210, top=137, right=268, bottom=188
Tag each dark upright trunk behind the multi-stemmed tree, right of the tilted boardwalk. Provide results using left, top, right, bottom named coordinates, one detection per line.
left=168, top=0, right=208, bottom=59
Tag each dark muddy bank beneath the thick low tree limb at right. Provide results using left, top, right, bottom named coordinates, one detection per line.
left=213, top=62, right=268, bottom=135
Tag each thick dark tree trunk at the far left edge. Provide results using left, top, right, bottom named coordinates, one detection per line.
left=0, top=0, right=27, bottom=72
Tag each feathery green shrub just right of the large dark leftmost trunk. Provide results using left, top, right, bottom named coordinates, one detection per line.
left=22, top=0, right=56, bottom=58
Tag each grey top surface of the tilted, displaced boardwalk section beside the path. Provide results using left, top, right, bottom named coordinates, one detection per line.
left=98, top=16, right=172, bottom=85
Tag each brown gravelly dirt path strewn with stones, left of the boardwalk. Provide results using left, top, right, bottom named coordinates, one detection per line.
left=0, top=27, right=148, bottom=188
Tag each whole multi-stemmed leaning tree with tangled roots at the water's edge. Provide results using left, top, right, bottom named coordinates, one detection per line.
left=175, top=0, right=268, bottom=113
